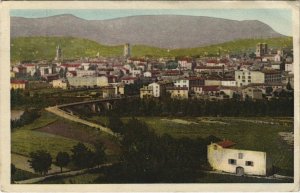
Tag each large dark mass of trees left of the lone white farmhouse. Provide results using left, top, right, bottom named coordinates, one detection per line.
left=99, top=114, right=220, bottom=183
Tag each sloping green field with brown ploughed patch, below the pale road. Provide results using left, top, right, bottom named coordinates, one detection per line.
left=11, top=112, right=118, bottom=164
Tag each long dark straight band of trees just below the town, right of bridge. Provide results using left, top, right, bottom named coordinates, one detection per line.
left=112, top=98, right=294, bottom=117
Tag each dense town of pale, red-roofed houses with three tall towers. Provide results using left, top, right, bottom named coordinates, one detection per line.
left=11, top=44, right=294, bottom=100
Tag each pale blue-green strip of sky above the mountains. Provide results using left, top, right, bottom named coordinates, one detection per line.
left=10, top=9, right=293, bottom=36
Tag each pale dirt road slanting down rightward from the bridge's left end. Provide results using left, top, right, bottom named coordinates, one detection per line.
left=46, top=106, right=116, bottom=136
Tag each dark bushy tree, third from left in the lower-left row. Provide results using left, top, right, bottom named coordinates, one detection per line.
left=71, top=142, right=93, bottom=168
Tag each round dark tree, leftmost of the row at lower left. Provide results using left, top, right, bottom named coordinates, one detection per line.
left=28, top=150, right=52, bottom=175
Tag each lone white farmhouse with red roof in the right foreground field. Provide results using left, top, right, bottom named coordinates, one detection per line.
left=207, top=141, right=272, bottom=176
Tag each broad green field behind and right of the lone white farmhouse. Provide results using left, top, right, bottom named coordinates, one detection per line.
left=86, top=117, right=294, bottom=176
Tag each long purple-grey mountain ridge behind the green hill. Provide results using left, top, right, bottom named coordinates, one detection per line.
left=11, top=14, right=284, bottom=49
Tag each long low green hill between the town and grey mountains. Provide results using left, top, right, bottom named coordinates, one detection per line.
left=11, top=37, right=292, bottom=63
